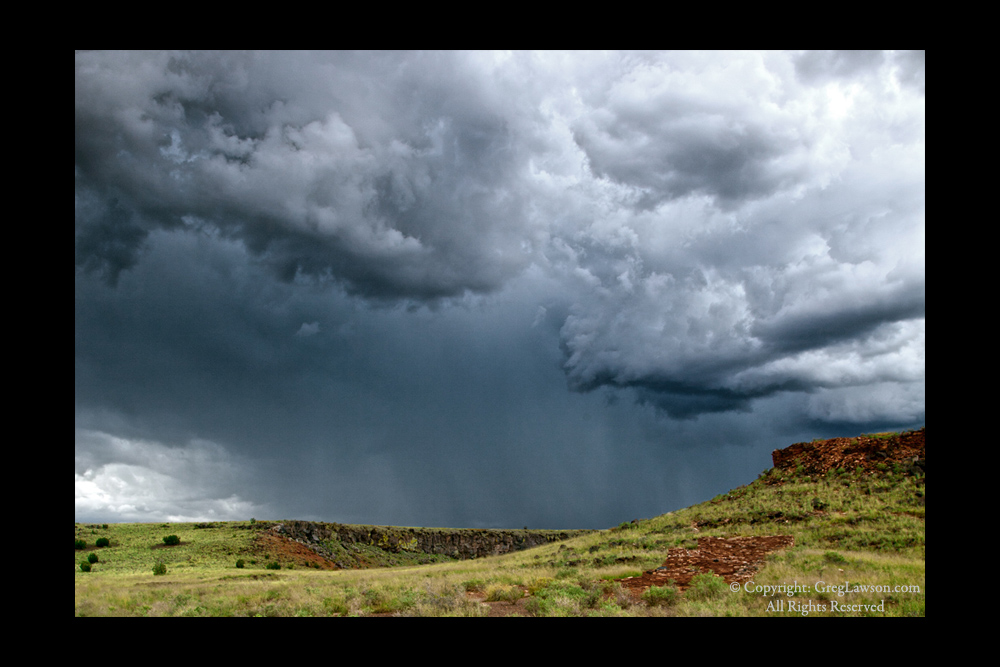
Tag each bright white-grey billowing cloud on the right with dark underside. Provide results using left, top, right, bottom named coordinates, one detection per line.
left=562, top=54, right=924, bottom=417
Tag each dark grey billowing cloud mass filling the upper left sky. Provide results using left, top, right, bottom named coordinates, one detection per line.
left=76, top=53, right=548, bottom=298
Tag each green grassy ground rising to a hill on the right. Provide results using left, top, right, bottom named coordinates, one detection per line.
left=75, top=434, right=925, bottom=616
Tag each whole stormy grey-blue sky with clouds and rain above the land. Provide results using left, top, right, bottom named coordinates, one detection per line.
left=75, top=51, right=925, bottom=528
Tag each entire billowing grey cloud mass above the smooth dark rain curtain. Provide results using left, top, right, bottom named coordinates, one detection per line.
left=76, top=52, right=923, bottom=422
